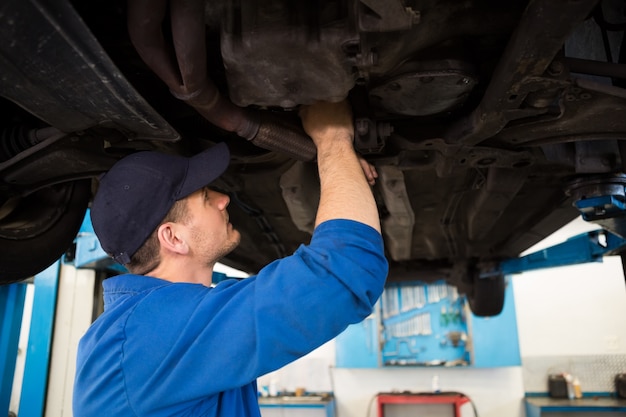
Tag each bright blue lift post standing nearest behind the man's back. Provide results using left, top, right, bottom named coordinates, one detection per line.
left=19, top=261, right=61, bottom=416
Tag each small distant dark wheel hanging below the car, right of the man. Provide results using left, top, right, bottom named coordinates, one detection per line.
left=467, top=274, right=505, bottom=317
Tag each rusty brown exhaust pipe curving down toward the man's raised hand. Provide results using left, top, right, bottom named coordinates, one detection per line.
left=128, top=0, right=317, bottom=161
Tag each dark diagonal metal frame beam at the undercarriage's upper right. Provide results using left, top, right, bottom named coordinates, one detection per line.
left=444, top=0, right=597, bottom=146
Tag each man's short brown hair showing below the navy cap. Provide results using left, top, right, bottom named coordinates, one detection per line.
left=125, top=198, right=189, bottom=275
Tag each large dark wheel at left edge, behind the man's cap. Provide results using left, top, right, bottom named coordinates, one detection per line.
left=0, top=180, right=91, bottom=284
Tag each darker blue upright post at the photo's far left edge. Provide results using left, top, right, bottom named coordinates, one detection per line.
left=0, top=282, right=27, bottom=416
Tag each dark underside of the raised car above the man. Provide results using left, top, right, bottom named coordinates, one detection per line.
left=0, top=0, right=626, bottom=316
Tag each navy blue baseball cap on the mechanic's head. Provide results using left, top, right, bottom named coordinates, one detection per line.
left=91, top=143, right=230, bottom=265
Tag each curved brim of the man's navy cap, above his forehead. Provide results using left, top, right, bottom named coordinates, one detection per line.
left=176, top=142, right=230, bottom=200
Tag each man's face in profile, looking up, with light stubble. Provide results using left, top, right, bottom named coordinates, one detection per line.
left=185, top=187, right=241, bottom=265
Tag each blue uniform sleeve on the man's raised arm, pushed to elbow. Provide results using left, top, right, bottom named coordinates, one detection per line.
left=123, top=220, right=388, bottom=413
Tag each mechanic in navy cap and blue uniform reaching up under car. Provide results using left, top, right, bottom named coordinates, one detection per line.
left=74, top=102, right=387, bottom=417
